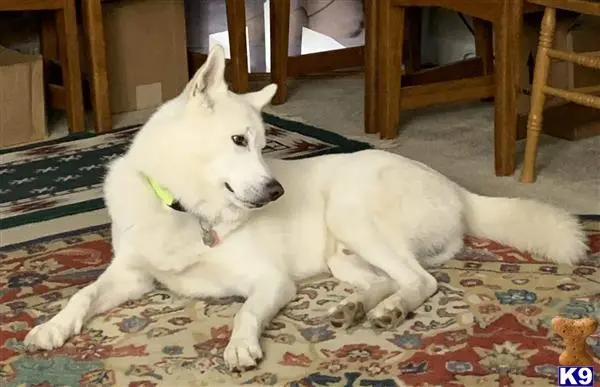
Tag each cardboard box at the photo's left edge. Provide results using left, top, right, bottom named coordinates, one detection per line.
left=0, top=46, right=46, bottom=147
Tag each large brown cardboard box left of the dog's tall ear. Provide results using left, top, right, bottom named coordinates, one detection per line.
left=91, top=0, right=189, bottom=113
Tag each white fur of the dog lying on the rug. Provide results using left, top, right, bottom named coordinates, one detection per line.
left=25, top=47, right=587, bottom=369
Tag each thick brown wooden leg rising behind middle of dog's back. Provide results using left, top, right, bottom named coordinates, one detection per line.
left=376, top=0, right=405, bottom=139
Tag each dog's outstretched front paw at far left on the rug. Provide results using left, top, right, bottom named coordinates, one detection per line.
left=23, top=318, right=82, bottom=350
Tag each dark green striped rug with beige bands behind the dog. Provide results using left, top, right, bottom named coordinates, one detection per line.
left=0, top=114, right=371, bottom=230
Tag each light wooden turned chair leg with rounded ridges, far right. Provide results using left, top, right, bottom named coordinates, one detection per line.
left=521, top=7, right=556, bottom=183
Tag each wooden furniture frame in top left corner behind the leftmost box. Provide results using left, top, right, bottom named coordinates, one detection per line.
left=0, top=0, right=85, bottom=132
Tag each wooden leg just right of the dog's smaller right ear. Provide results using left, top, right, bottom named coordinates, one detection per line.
left=269, top=0, right=290, bottom=105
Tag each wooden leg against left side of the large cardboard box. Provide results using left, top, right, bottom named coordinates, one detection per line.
left=82, top=0, right=112, bottom=132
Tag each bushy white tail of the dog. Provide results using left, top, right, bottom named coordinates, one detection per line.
left=462, top=189, right=588, bottom=264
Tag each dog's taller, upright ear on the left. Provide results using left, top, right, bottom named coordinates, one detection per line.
left=185, top=45, right=227, bottom=98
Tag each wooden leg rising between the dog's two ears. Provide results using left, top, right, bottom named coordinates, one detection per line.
left=225, top=0, right=248, bottom=93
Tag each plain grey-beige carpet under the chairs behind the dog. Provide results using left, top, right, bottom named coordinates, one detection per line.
left=267, top=76, right=600, bottom=214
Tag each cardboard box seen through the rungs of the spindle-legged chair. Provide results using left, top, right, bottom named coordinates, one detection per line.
left=518, top=14, right=600, bottom=116
